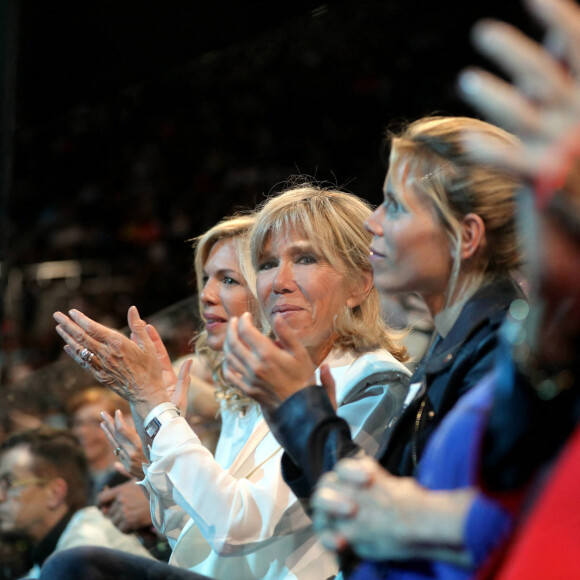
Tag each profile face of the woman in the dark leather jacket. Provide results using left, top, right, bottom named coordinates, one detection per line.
left=367, top=165, right=452, bottom=313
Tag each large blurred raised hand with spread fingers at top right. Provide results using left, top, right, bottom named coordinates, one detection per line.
left=459, top=0, right=580, bottom=196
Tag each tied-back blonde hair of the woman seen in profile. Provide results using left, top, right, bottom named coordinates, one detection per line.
left=389, top=117, right=521, bottom=297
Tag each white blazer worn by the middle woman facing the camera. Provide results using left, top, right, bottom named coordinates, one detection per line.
left=142, top=351, right=410, bottom=580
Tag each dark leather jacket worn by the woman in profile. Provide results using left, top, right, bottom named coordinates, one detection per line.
left=268, top=279, right=521, bottom=499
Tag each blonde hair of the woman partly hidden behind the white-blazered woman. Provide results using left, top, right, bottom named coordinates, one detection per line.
left=192, top=214, right=256, bottom=407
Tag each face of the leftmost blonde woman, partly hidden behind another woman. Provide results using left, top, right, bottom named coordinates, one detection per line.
left=200, top=238, right=252, bottom=350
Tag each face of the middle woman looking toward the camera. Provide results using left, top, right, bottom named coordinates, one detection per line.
left=256, top=229, right=356, bottom=365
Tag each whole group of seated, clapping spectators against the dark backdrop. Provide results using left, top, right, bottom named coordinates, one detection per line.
left=0, top=0, right=580, bottom=580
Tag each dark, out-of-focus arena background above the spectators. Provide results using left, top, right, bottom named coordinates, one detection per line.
left=0, top=0, right=536, bottom=384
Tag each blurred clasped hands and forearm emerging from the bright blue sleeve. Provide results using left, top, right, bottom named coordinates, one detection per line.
left=311, top=457, right=474, bottom=562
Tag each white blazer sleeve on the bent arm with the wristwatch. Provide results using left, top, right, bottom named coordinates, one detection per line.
left=144, top=418, right=302, bottom=555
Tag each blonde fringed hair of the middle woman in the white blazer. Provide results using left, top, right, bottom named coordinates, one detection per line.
left=250, top=183, right=408, bottom=361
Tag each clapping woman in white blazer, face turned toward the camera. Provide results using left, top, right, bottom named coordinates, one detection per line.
left=49, top=185, right=409, bottom=578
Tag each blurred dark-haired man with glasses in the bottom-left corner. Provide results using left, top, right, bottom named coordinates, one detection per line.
left=0, top=427, right=153, bottom=578
